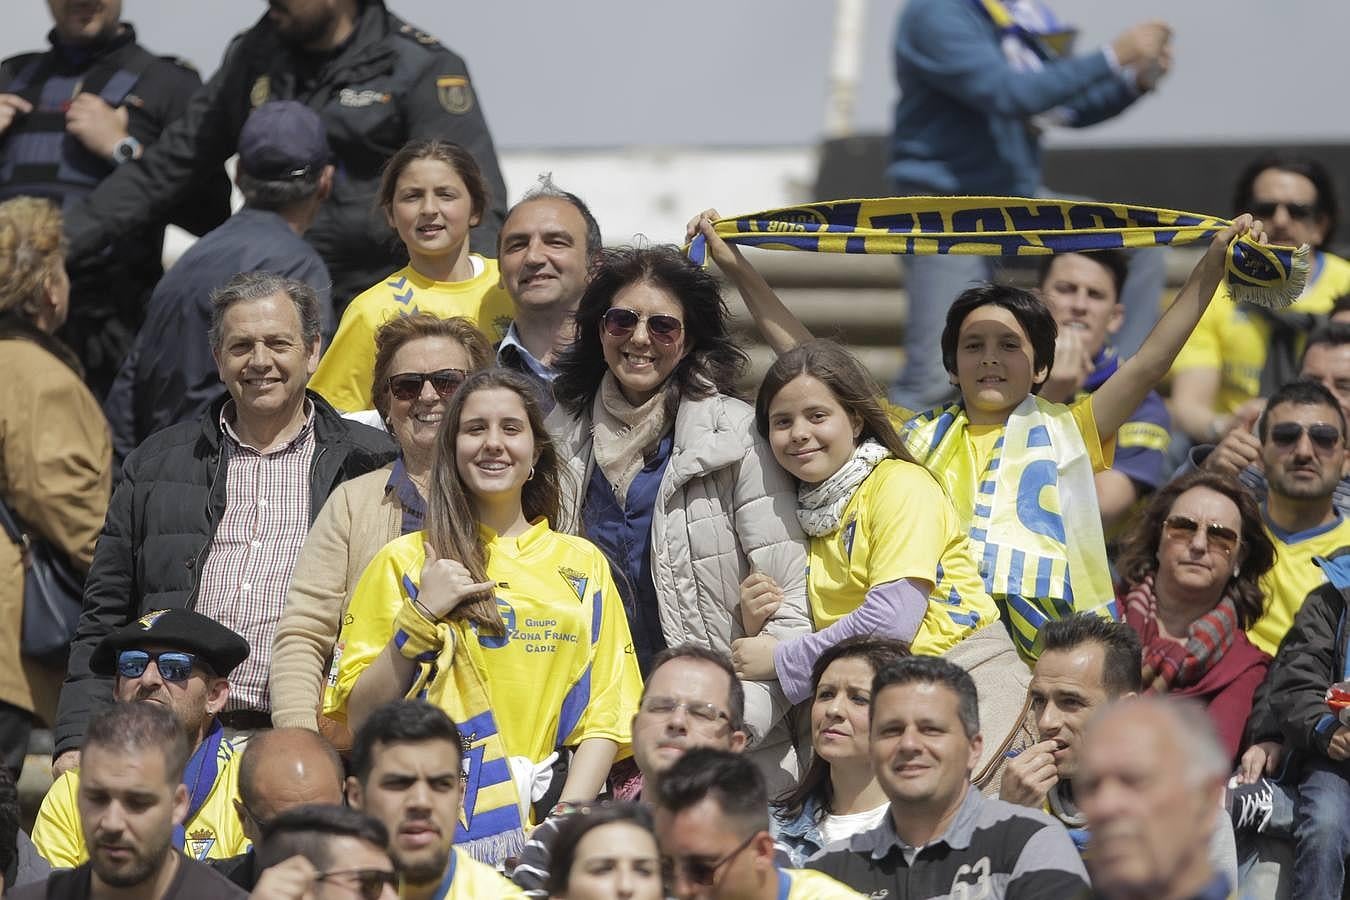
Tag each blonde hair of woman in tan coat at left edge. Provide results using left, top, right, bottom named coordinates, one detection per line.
left=0, top=197, right=66, bottom=318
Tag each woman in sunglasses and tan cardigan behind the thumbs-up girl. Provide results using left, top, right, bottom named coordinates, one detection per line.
left=271, top=313, right=493, bottom=749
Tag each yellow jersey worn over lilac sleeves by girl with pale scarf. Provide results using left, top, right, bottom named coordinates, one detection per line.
left=806, top=459, right=999, bottom=656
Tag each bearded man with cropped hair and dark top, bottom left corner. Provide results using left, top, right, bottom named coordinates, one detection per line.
left=9, top=703, right=248, bottom=900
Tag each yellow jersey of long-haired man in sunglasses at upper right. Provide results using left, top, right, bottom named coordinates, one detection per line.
left=1170, top=251, right=1350, bottom=416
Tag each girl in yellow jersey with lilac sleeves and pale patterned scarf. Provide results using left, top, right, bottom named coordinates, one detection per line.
left=734, top=340, right=1029, bottom=781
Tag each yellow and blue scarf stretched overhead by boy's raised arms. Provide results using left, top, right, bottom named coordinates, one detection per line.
left=689, top=197, right=1312, bottom=309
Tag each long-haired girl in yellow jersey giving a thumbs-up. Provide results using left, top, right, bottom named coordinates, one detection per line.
left=324, top=368, right=641, bottom=864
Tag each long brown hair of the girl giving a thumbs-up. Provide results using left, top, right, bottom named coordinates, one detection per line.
left=427, top=368, right=560, bottom=634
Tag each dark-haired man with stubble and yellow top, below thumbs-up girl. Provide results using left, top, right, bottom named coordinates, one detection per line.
left=347, top=700, right=524, bottom=900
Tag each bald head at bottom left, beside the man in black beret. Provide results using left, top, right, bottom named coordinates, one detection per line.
left=235, top=729, right=343, bottom=843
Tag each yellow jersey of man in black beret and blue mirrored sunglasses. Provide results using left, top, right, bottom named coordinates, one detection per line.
left=32, top=741, right=250, bottom=869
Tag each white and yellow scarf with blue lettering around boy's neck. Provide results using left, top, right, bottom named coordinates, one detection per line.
left=903, top=395, right=1118, bottom=663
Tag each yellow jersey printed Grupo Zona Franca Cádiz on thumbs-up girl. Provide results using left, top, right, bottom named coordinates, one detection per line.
left=324, top=519, right=643, bottom=762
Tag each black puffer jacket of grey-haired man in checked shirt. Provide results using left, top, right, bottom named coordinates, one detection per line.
left=55, top=391, right=397, bottom=754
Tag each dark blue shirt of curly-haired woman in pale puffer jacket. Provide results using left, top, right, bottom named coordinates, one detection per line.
left=582, top=433, right=675, bottom=677
